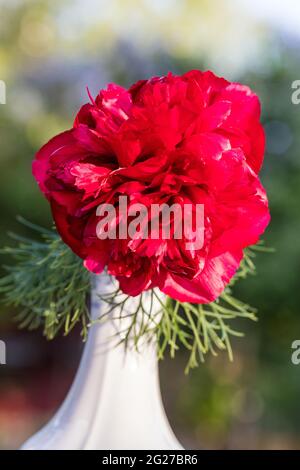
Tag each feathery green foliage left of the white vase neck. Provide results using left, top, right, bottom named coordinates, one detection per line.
left=0, top=219, right=90, bottom=339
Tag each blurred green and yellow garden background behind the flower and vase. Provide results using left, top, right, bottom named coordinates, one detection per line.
left=0, top=0, right=300, bottom=449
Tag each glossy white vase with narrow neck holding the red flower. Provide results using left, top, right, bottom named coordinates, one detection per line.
left=21, top=274, right=182, bottom=450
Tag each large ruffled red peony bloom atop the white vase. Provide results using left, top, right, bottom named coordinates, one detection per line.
left=33, top=70, right=270, bottom=303
